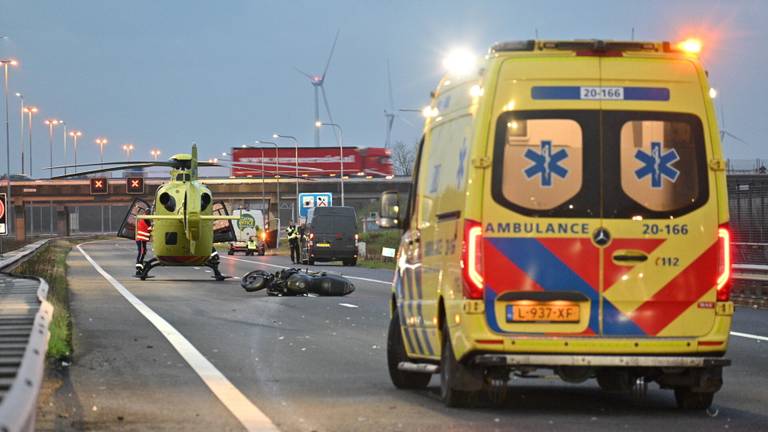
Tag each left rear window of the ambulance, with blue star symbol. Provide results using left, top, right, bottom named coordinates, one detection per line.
left=493, top=111, right=599, bottom=217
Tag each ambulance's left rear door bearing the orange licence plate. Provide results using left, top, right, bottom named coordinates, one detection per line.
left=481, top=54, right=603, bottom=337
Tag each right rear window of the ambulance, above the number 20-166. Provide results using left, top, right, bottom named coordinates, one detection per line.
left=605, top=111, right=708, bottom=218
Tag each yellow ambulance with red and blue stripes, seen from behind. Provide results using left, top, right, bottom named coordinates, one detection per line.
left=380, top=40, right=734, bottom=409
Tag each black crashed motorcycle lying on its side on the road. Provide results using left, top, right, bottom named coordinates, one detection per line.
left=240, top=268, right=355, bottom=297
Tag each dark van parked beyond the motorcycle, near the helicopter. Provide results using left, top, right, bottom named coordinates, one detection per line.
left=305, top=207, right=357, bottom=266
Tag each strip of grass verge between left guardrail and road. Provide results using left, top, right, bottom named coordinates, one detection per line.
left=13, top=240, right=73, bottom=360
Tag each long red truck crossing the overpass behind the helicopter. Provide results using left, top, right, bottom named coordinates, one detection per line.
left=232, top=147, right=394, bottom=177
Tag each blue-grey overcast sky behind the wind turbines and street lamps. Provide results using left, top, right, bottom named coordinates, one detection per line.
left=0, top=0, right=768, bottom=175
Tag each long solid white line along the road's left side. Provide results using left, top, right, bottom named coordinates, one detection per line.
left=77, top=245, right=278, bottom=432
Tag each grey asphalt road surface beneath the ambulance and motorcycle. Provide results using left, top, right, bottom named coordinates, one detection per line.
left=40, top=241, right=768, bottom=431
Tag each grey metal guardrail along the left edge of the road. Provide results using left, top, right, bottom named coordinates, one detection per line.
left=0, top=240, right=53, bottom=432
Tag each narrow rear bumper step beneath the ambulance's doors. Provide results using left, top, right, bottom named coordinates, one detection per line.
left=472, top=354, right=731, bottom=368
